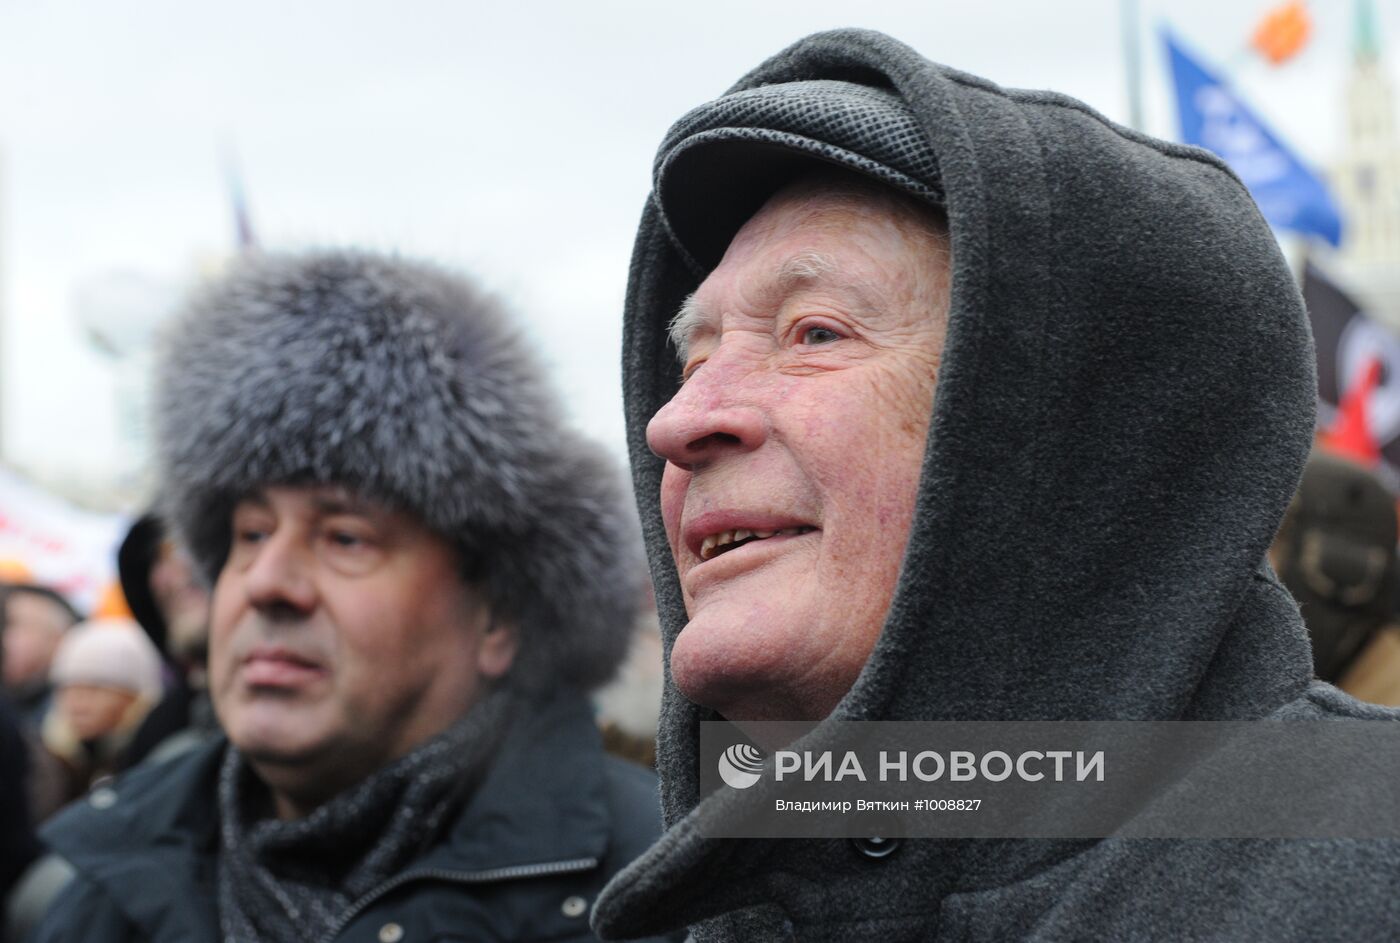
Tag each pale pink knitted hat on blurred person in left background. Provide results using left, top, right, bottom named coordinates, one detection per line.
left=49, top=618, right=161, bottom=698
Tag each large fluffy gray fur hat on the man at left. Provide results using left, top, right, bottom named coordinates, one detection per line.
left=155, top=252, right=643, bottom=690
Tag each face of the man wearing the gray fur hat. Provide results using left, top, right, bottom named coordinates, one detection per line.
left=209, top=487, right=515, bottom=811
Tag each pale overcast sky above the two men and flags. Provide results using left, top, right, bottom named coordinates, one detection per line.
left=0, top=0, right=1383, bottom=498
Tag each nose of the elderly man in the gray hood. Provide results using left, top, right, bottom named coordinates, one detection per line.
left=647, top=353, right=769, bottom=472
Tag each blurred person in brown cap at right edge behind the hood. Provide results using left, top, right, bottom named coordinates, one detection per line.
left=1268, top=451, right=1400, bottom=707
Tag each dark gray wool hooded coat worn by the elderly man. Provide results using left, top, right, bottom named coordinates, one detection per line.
left=594, top=31, right=1400, bottom=942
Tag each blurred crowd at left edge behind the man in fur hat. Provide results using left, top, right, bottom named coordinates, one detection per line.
left=0, top=513, right=217, bottom=890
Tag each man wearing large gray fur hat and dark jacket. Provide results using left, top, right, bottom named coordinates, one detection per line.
left=21, top=247, right=658, bottom=943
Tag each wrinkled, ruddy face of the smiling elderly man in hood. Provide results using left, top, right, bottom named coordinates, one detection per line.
left=647, top=176, right=949, bottom=721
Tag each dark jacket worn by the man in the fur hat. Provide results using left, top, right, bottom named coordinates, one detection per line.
left=31, top=700, right=672, bottom=943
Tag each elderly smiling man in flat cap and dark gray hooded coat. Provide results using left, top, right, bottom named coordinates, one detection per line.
left=595, top=31, right=1400, bottom=942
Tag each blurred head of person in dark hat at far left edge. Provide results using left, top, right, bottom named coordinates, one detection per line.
left=0, top=583, right=81, bottom=729
